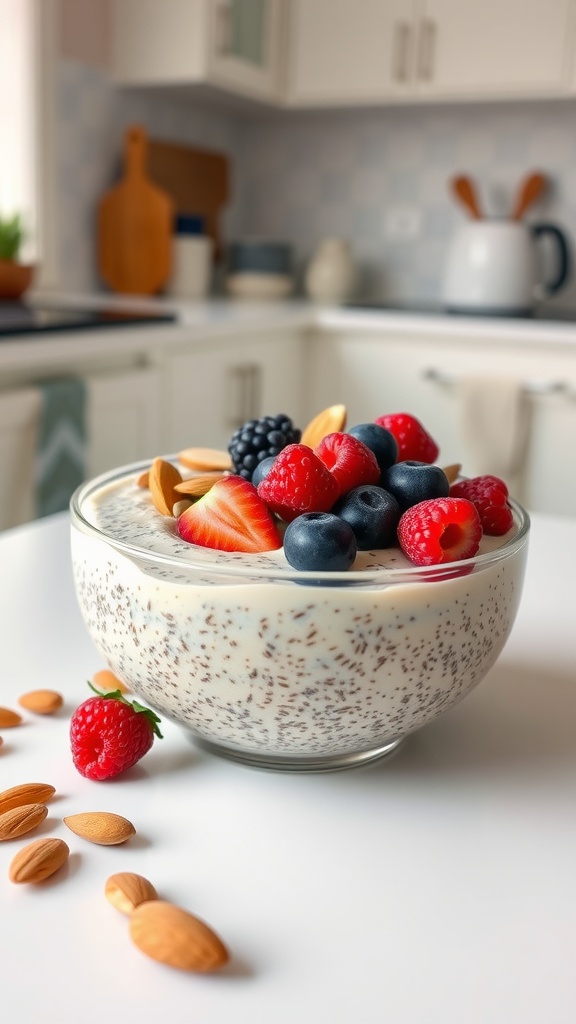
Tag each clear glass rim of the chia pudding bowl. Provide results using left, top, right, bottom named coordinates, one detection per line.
left=70, top=455, right=530, bottom=587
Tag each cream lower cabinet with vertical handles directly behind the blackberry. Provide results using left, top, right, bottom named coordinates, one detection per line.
left=163, top=332, right=303, bottom=452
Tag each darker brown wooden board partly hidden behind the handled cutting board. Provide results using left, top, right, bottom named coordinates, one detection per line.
left=148, top=139, right=230, bottom=259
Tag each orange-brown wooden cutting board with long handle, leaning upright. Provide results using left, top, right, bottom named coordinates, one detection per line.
left=97, top=125, right=174, bottom=295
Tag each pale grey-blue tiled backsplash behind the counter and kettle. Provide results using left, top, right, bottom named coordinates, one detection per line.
left=58, top=59, right=576, bottom=306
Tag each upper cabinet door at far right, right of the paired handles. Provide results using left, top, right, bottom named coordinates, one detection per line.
left=416, top=0, right=574, bottom=96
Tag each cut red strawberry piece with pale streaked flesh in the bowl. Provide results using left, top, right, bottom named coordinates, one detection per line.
left=178, top=476, right=282, bottom=553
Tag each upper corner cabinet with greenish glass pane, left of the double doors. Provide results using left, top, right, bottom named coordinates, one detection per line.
left=111, top=0, right=284, bottom=100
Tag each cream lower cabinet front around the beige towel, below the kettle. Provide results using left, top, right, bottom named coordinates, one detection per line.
left=306, top=331, right=576, bottom=516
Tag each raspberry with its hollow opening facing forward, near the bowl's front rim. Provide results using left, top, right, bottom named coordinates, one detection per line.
left=398, top=498, right=482, bottom=565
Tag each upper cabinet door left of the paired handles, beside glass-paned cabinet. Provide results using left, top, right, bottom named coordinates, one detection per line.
left=289, top=0, right=416, bottom=105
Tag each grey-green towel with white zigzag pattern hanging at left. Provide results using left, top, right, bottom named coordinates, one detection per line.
left=36, top=377, right=87, bottom=518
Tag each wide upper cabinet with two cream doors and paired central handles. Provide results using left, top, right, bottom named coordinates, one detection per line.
left=288, top=0, right=576, bottom=106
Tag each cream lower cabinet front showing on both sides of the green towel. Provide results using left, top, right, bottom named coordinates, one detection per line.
left=0, top=367, right=160, bottom=529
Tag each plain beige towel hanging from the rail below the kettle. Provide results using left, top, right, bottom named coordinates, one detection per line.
left=456, top=376, right=530, bottom=501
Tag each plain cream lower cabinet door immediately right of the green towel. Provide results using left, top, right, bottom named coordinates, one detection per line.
left=86, top=368, right=161, bottom=476
